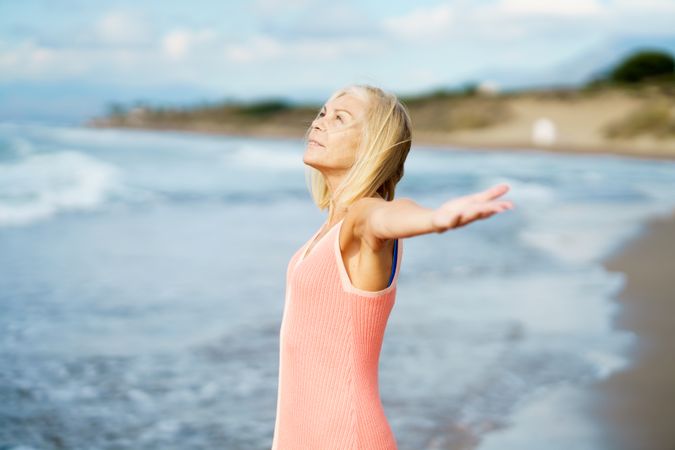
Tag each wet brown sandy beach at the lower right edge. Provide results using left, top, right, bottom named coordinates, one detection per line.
left=594, top=211, right=675, bottom=450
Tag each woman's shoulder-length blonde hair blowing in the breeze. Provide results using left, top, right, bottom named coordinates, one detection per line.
left=305, top=84, right=412, bottom=210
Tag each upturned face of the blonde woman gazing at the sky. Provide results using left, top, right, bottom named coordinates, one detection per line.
left=303, top=94, right=366, bottom=174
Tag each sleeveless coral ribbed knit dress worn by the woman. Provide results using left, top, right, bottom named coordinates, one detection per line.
left=272, top=219, right=403, bottom=450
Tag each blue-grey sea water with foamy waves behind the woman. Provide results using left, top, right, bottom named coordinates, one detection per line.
left=0, top=123, right=675, bottom=450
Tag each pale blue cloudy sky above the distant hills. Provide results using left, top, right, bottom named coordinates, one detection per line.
left=0, top=0, right=675, bottom=121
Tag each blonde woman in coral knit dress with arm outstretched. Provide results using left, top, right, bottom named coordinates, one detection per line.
left=272, top=85, right=513, bottom=450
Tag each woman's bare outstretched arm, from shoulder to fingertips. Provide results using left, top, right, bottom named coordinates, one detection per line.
left=354, top=184, right=514, bottom=246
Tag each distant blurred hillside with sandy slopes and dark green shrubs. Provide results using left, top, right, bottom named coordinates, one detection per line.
left=88, top=50, right=675, bottom=157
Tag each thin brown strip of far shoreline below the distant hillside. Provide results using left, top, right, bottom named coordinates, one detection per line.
left=87, top=124, right=675, bottom=161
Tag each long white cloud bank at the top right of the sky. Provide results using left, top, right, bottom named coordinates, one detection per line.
left=379, top=0, right=675, bottom=45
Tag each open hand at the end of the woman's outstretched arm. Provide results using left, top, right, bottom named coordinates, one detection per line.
left=431, top=184, right=514, bottom=233
